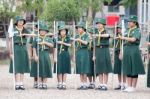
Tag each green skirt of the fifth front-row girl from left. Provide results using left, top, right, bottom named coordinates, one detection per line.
left=96, top=48, right=112, bottom=74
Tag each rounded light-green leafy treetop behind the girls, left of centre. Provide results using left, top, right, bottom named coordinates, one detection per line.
left=41, top=0, right=80, bottom=21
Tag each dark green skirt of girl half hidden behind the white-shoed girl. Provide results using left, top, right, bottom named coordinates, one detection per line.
left=114, top=50, right=122, bottom=74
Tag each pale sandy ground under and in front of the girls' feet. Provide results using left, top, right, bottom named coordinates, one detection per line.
left=0, top=66, right=150, bottom=99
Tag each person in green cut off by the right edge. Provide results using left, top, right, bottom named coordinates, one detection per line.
left=147, top=36, right=150, bottom=88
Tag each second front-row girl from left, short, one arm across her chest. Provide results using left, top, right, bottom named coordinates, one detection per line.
left=33, top=24, right=53, bottom=89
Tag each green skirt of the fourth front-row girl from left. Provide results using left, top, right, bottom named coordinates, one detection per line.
left=76, top=48, right=90, bottom=74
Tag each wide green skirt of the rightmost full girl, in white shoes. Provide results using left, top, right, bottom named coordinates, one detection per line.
left=123, top=46, right=145, bottom=75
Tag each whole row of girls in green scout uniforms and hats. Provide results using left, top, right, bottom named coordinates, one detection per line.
left=10, top=16, right=149, bottom=92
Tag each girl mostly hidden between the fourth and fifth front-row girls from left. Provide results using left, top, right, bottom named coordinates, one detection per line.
left=87, top=28, right=95, bottom=89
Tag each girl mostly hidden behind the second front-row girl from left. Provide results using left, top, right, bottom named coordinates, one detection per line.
left=29, top=24, right=38, bottom=88
